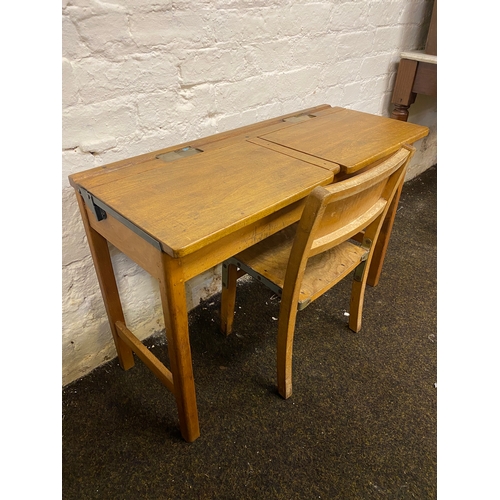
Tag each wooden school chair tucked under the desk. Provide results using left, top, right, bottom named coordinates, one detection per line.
left=221, top=145, right=415, bottom=399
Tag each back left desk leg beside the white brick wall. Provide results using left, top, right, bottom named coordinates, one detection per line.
left=76, top=192, right=134, bottom=370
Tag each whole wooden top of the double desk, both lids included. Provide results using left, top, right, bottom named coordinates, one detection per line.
left=69, top=105, right=428, bottom=257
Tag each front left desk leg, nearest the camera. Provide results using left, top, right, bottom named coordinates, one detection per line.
left=160, top=254, right=200, bottom=442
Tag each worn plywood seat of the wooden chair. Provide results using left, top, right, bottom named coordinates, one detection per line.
left=234, top=223, right=367, bottom=310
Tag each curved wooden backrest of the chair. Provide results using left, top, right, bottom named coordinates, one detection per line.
left=284, top=145, right=415, bottom=296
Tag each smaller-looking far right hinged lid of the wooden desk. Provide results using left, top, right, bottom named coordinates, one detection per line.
left=252, top=107, right=429, bottom=174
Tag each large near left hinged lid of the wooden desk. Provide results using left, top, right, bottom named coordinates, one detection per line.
left=75, top=141, right=333, bottom=257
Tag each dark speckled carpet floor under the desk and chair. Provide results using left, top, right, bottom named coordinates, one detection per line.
left=62, top=167, right=437, bottom=500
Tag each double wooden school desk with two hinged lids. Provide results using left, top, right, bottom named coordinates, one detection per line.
left=69, top=105, right=428, bottom=442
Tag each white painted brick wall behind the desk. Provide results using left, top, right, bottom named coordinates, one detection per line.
left=62, top=0, right=437, bottom=384
